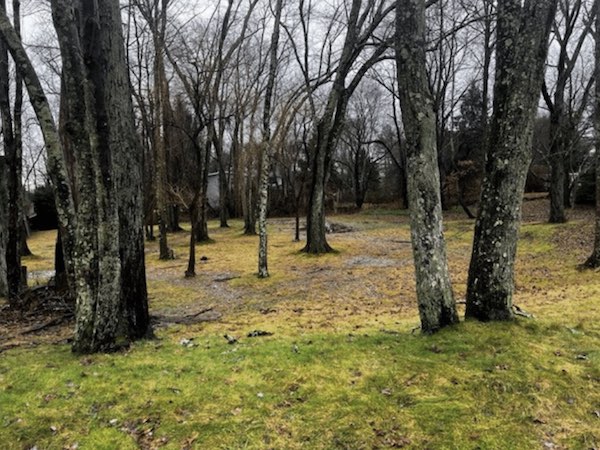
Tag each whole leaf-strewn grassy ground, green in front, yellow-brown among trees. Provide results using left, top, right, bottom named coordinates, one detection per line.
left=0, top=199, right=600, bottom=449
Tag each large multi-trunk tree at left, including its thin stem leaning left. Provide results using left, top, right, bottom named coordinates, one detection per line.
left=0, top=0, right=149, bottom=353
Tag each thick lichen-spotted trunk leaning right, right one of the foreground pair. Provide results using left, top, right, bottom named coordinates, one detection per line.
left=466, top=0, right=557, bottom=321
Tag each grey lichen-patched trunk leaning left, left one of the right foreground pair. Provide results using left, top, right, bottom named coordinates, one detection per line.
left=396, top=0, right=458, bottom=333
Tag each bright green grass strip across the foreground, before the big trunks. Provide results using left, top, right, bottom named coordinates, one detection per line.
left=0, top=322, right=600, bottom=449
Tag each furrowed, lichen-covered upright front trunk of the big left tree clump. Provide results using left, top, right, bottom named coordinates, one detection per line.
left=52, top=0, right=122, bottom=353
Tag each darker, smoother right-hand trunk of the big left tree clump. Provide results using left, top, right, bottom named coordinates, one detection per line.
left=94, top=0, right=151, bottom=339
